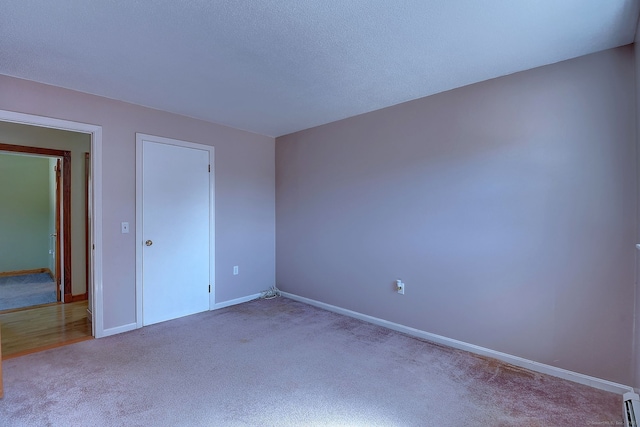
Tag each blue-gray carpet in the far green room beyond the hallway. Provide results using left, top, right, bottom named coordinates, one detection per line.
left=0, top=273, right=56, bottom=311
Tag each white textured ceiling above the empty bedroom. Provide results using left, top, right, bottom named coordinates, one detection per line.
left=0, top=0, right=639, bottom=136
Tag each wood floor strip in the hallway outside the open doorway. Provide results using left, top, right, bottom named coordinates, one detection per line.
left=0, top=301, right=93, bottom=360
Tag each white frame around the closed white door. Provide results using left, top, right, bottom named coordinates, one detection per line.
left=136, top=133, right=216, bottom=328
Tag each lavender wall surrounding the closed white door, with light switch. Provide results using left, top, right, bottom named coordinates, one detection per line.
left=0, top=76, right=275, bottom=329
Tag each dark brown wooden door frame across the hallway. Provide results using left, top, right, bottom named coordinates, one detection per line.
left=0, top=143, right=72, bottom=302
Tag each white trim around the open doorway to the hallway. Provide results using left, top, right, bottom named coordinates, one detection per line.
left=0, top=110, right=104, bottom=338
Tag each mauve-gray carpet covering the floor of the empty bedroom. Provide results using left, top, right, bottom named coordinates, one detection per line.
left=0, top=298, right=622, bottom=427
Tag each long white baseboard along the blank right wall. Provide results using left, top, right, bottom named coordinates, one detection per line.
left=280, top=292, right=634, bottom=395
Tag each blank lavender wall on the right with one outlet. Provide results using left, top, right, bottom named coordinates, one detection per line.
left=276, top=46, right=637, bottom=383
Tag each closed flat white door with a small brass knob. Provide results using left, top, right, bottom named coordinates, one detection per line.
left=138, top=136, right=212, bottom=325
